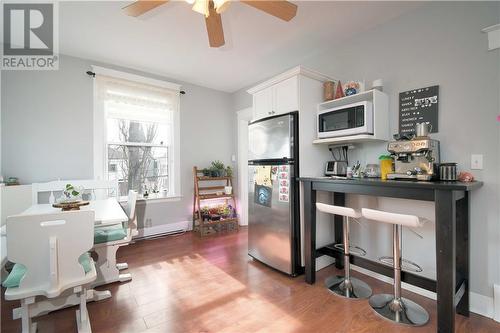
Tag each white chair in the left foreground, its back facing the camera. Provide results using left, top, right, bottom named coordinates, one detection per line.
left=4, top=211, right=97, bottom=333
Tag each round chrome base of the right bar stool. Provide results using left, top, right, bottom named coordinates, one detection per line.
left=369, top=294, right=429, bottom=326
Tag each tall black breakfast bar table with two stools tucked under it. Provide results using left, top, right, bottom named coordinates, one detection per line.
left=298, top=177, right=483, bottom=333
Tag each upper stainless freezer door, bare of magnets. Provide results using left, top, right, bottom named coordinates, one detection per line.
left=248, top=114, right=294, bottom=161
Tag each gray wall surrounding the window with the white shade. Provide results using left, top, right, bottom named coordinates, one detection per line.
left=1, top=56, right=236, bottom=226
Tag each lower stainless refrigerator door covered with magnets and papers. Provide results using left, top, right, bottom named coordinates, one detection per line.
left=248, top=165, right=295, bottom=274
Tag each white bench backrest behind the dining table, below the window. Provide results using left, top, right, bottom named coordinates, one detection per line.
left=31, top=179, right=119, bottom=205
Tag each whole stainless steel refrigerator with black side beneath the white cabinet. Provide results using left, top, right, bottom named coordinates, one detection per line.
left=248, top=112, right=302, bottom=276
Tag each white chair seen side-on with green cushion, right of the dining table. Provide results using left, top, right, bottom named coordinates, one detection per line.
left=94, top=191, right=138, bottom=286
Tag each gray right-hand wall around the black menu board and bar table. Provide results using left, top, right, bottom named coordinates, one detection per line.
left=233, top=2, right=500, bottom=296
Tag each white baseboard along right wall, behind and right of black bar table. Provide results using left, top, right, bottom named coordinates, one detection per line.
left=351, top=265, right=500, bottom=321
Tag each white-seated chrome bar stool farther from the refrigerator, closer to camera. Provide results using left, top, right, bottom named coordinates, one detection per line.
left=361, top=208, right=429, bottom=326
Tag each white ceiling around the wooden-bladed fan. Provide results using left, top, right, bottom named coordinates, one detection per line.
left=59, top=1, right=418, bottom=92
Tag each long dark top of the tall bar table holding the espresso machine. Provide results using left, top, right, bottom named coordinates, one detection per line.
left=298, top=177, right=483, bottom=191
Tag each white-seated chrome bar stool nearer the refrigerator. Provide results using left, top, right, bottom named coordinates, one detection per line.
left=316, top=203, right=372, bottom=298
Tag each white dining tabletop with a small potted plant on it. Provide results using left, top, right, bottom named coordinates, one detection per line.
left=21, top=198, right=128, bottom=226
